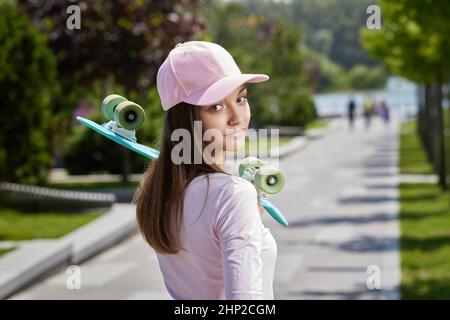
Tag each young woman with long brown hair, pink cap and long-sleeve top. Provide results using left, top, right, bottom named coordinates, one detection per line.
left=135, top=41, right=277, bottom=300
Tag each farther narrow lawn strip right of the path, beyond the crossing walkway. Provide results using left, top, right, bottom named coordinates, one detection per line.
left=399, top=120, right=433, bottom=174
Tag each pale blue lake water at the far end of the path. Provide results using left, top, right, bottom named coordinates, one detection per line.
left=314, top=77, right=418, bottom=118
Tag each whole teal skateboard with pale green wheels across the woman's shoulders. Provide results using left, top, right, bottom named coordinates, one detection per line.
left=77, top=94, right=289, bottom=227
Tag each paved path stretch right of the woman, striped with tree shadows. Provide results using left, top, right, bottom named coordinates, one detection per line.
left=270, top=115, right=400, bottom=299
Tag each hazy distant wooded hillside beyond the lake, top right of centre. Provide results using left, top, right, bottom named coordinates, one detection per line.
left=223, top=0, right=386, bottom=92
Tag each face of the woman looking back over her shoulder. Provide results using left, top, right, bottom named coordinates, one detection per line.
left=199, top=84, right=251, bottom=151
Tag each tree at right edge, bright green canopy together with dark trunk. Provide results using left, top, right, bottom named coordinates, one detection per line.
left=361, top=0, right=450, bottom=187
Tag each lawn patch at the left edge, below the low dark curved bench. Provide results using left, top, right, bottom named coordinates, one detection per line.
left=0, top=208, right=102, bottom=241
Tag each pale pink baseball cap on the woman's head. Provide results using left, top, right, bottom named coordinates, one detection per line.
left=156, top=41, right=269, bottom=110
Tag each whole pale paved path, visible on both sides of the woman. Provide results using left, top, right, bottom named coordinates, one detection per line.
left=7, top=115, right=400, bottom=299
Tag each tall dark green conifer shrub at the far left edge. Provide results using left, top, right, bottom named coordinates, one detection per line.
left=0, top=1, right=58, bottom=184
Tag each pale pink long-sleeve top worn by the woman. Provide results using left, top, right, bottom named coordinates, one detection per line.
left=157, top=173, right=277, bottom=300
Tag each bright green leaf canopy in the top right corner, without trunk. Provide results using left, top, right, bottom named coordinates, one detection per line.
left=360, top=0, right=450, bottom=83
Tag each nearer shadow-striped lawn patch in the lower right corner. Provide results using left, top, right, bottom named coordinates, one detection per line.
left=400, top=184, right=450, bottom=299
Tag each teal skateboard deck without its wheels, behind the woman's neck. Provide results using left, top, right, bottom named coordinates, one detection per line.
left=77, top=105, right=289, bottom=227
